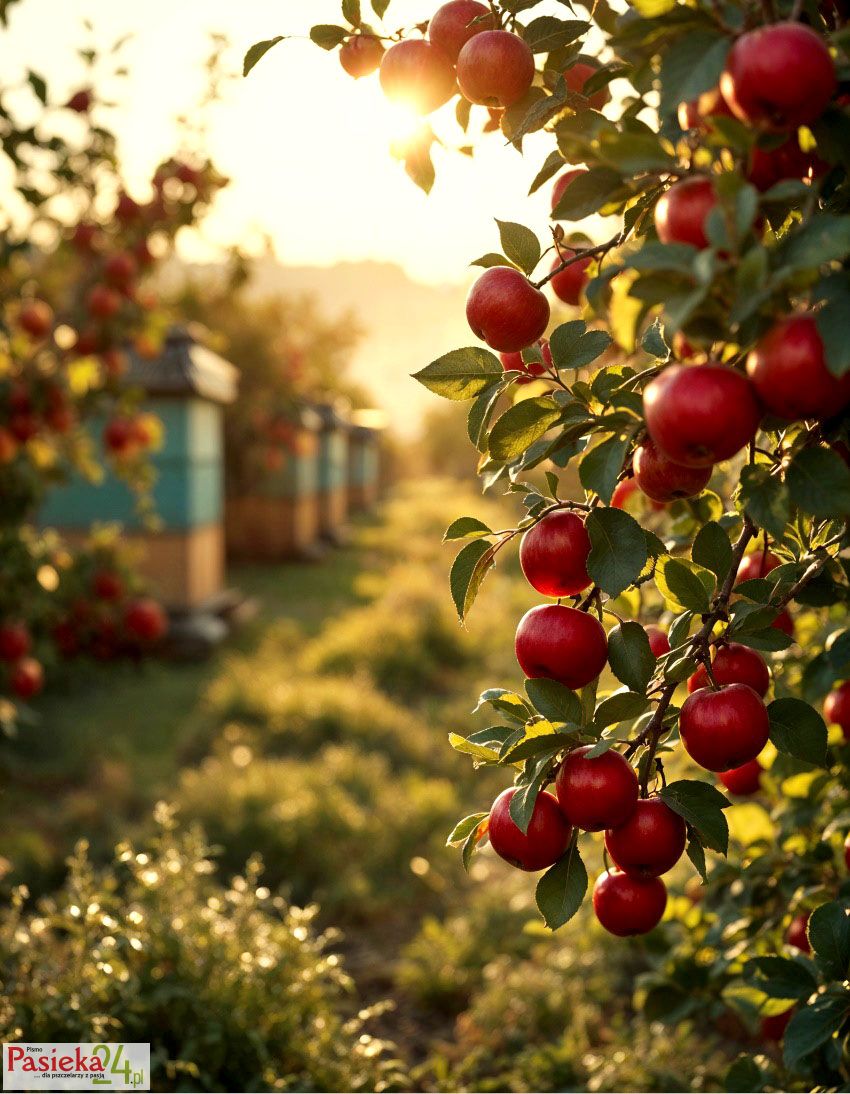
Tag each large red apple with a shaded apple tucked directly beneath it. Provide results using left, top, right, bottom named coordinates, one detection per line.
left=643, top=363, right=761, bottom=467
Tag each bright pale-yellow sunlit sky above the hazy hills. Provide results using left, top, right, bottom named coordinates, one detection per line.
left=0, top=0, right=595, bottom=284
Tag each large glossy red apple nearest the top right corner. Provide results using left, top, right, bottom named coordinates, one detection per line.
left=720, top=23, right=836, bottom=129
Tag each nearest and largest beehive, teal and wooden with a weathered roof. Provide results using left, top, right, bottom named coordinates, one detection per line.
left=39, top=327, right=238, bottom=609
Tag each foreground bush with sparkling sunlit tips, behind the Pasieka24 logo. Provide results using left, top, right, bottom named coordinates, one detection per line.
left=0, top=816, right=406, bottom=1091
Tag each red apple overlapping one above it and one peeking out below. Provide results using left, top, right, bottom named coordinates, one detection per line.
left=679, top=684, right=770, bottom=771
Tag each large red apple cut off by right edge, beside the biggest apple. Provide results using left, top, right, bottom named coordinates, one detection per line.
left=747, top=315, right=850, bottom=421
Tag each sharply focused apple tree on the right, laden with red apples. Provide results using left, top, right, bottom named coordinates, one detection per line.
left=251, top=0, right=850, bottom=1090
